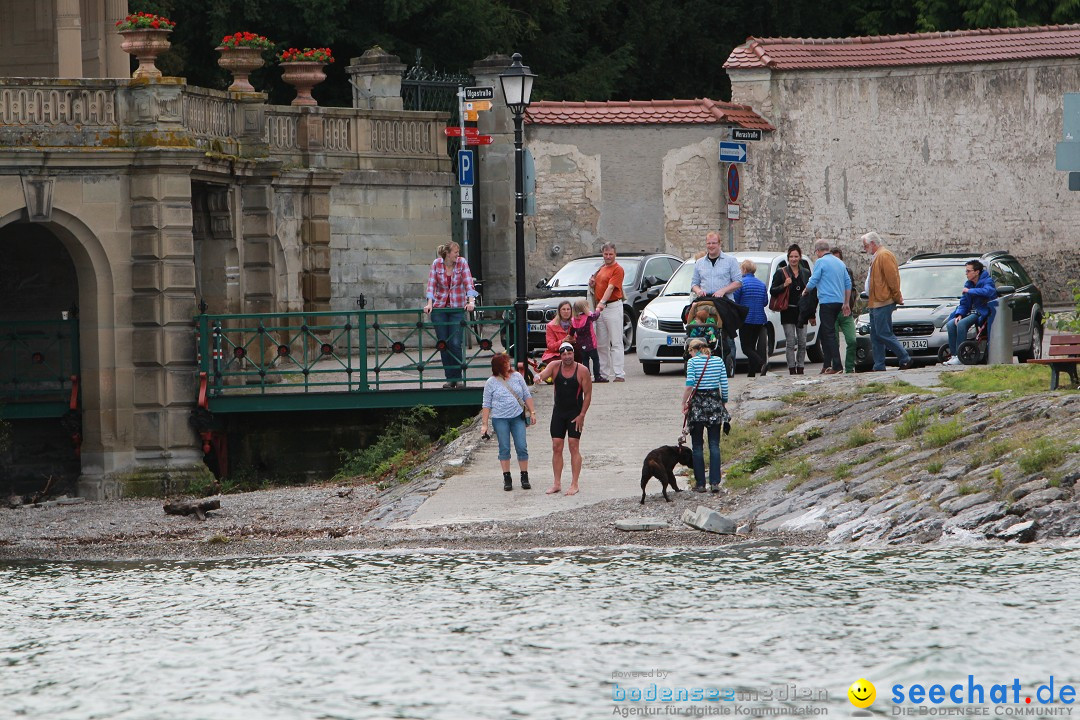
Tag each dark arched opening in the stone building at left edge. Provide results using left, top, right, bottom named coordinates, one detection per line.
left=0, top=222, right=82, bottom=494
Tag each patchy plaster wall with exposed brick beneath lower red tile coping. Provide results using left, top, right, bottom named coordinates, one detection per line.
left=527, top=125, right=727, bottom=283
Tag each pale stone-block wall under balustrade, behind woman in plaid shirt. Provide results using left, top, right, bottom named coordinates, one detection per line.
left=330, top=171, right=455, bottom=311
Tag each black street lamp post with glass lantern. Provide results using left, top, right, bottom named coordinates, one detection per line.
left=499, top=53, right=536, bottom=369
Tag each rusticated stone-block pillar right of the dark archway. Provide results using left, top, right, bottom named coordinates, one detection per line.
left=125, top=150, right=207, bottom=494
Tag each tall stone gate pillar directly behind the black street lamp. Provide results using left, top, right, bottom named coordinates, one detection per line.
left=472, top=55, right=517, bottom=304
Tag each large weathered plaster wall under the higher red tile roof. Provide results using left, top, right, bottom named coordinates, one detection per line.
left=730, top=60, right=1080, bottom=300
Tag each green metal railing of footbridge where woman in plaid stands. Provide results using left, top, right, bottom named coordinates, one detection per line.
left=195, top=305, right=513, bottom=412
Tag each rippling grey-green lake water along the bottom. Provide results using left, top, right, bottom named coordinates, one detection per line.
left=0, top=547, right=1080, bottom=720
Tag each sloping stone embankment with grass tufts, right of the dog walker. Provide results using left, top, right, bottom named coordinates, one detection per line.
left=721, top=370, right=1080, bottom=544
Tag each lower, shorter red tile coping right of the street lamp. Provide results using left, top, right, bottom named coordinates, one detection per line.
left=525, top=97, right=774, bottom=130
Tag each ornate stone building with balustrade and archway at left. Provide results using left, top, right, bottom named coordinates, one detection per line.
left=0, top=15, right=453, bottom=498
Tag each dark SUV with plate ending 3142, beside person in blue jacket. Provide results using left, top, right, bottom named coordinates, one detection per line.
left=855, top=250, right=1042, bottom=368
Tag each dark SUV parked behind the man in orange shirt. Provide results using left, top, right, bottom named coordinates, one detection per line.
left=527, top=253, right=683, bottom=351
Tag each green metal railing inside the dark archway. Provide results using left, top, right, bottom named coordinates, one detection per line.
left=0, top=318, right=79, bottom=419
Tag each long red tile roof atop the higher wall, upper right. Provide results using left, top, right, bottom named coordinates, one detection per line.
left=724, top=25, right=1080, bottom=70
